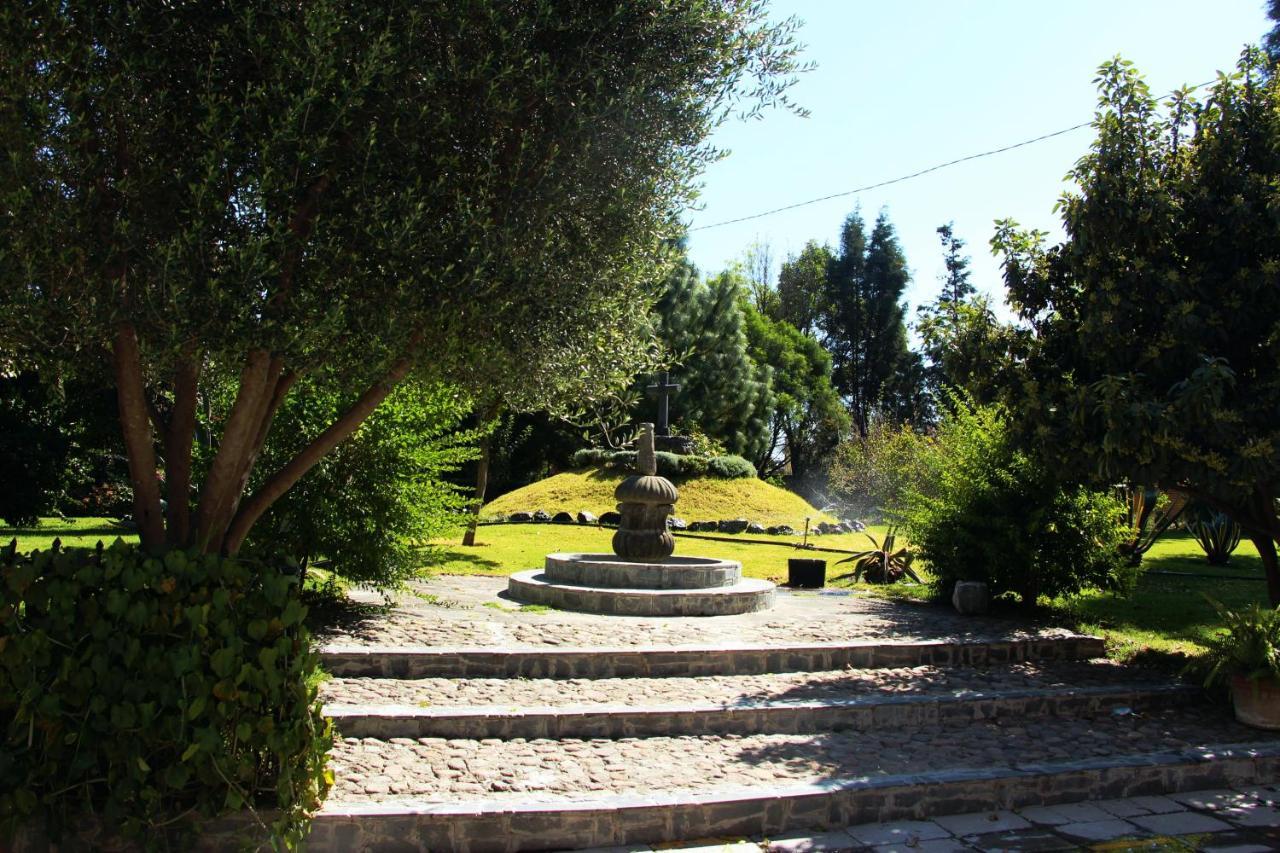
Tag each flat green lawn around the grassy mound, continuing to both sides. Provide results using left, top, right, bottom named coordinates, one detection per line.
left=0, top=519, right=1266, bottom=660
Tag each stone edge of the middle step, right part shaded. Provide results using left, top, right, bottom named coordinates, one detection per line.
left=325, top=684, right=1202, bottom=740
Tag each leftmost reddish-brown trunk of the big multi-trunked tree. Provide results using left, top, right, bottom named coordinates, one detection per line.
left=111, top=323, right=164, bottom=552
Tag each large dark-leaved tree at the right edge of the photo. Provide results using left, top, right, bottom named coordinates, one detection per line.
left=995, top=49, right=1280, bottom=605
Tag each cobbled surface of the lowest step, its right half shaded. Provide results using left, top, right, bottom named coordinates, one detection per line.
left=329, top=710, right=1266, bottom=804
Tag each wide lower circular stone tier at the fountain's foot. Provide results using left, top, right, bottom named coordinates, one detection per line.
left=507, top=564, right=774, bottom=616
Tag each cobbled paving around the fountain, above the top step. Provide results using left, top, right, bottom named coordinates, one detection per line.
left=312, top=576, right=1068, bottom=649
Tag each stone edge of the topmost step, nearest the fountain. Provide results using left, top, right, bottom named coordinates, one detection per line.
left=320, top=634, right=1106, bottom=679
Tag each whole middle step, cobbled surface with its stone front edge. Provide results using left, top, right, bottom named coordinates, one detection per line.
left=320, top=660, right=1201, bottom=738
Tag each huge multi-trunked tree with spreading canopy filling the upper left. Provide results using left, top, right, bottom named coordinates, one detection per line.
left=0, top=0, right=796, bottom=553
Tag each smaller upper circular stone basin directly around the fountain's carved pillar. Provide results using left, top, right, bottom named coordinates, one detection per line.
left=544, top=553, right=742, bottom=589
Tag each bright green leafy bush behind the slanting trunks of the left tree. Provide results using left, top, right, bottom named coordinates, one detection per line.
left=248, top=382, right=477, bottom=588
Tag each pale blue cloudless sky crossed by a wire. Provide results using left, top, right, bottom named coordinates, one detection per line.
left=686, top=0, right=1270, bottom=316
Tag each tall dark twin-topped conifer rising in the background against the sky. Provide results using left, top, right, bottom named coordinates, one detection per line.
left=819, top=210, right=910, bottom=435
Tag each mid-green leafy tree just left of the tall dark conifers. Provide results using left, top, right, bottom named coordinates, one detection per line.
left=742, top=305, right=849, bottom=481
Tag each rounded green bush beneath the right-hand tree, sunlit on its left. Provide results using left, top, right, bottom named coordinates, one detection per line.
left=902, top=402, right=1137, bottom=606
